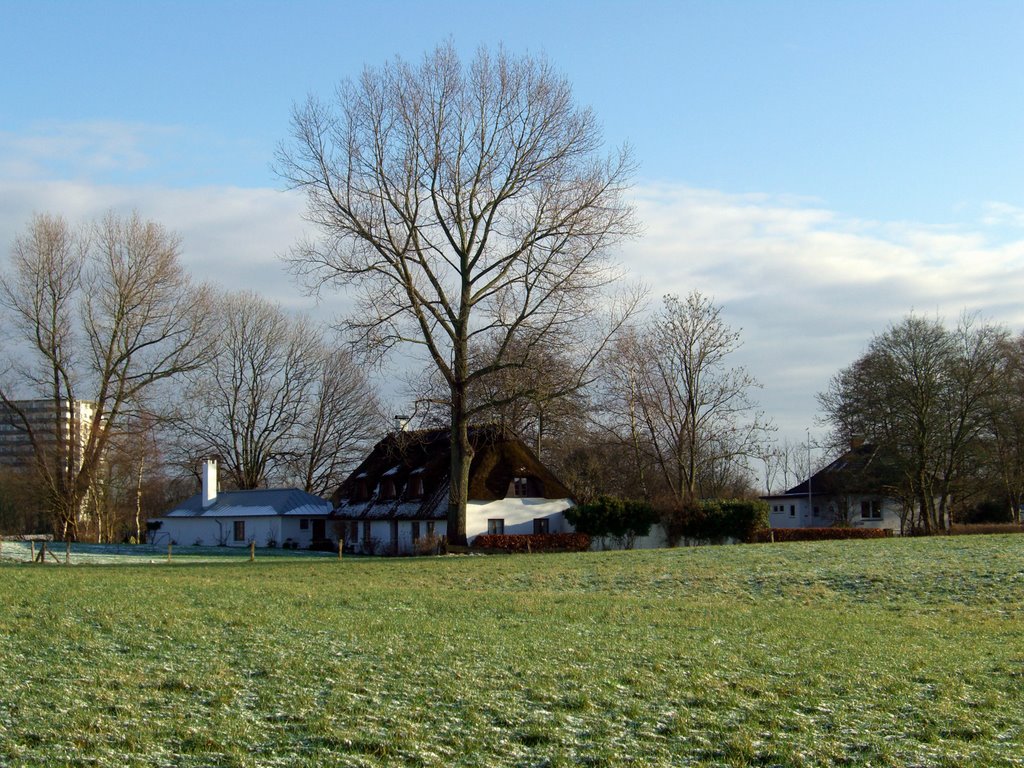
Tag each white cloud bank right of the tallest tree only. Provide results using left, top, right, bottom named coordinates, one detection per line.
left=623, top=185, right=1024, bottom=438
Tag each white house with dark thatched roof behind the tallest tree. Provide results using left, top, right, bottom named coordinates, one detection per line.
left=332, top=426, right=572, bottom=554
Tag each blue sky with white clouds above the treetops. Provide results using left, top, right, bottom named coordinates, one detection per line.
left=0, top=0, right=1024, bottom=444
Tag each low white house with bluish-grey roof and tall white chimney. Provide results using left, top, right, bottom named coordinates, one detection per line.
left=147, top=459, right=338, bottom=549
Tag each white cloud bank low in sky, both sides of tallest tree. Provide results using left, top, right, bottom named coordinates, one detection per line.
left=0, top=167, right=1024, bottom=439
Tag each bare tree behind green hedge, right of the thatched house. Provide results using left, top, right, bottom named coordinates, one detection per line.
left=602, top=291, right=773, bottom=509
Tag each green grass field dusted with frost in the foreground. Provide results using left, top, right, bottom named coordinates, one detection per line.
left=0, top=536, right=1024, bottom=766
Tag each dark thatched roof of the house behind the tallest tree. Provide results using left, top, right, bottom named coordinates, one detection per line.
left=333, top=425, right=571, bottom=520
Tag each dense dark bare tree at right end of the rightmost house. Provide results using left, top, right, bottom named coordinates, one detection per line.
left=818, top=314, right=1008, bottom=532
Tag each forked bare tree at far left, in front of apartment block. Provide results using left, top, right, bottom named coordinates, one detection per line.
left=0, top=213, right=208, bottom=538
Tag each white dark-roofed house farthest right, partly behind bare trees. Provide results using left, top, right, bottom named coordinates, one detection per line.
left=762, top=442, right=903, bottom=532
